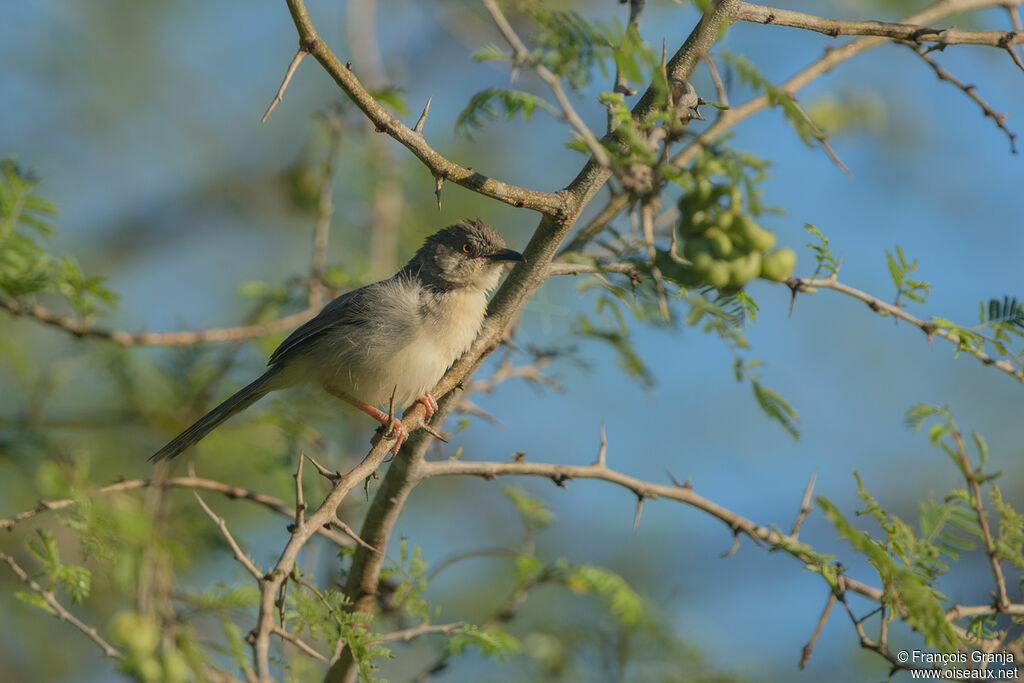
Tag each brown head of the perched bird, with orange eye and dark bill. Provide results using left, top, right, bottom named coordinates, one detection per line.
left=406, top=218, right=526, bottom=291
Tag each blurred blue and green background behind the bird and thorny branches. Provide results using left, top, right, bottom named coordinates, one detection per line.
left=0, top=0, right=1024, bottom=681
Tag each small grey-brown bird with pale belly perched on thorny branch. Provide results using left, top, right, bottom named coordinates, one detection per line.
left=150, top=217, right=525, bottom=462
